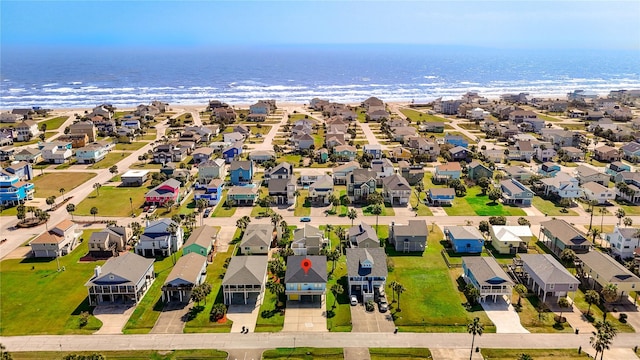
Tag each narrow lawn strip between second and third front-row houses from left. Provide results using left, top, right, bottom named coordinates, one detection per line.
left=184, top=248, right=240, bottom=333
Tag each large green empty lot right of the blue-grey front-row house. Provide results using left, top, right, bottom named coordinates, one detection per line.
left=387, top=228, right=495, bottom=332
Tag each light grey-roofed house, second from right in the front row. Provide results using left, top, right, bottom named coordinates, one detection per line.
left=520, top=254, right=580, bottom=303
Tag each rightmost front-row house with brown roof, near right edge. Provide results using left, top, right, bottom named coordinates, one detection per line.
left=578, top=251, right=640, bottom=301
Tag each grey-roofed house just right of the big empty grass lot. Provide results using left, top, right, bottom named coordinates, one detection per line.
left=462, top=256, right=514, bottom=302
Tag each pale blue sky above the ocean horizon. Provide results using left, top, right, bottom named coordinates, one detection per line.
left=0, top=0, right=640, bottom=50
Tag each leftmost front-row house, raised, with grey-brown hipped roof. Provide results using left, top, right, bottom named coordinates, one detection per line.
left=84, top=252, right=155, bottom=306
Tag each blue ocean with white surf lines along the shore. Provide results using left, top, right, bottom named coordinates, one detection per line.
left=0, top=45, right=640, bottom=109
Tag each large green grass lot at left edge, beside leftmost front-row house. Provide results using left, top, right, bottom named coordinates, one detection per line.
left=0, top=230, right=104, bottom=336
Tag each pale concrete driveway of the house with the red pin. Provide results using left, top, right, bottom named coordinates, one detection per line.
left=282, top=296, right=327, bottom=332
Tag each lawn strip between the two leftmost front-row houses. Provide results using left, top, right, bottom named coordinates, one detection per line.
left=123, top=254, right=179, bottom=334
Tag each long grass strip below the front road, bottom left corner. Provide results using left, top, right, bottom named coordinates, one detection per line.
left=11, top=349, right=228, bottom=360
